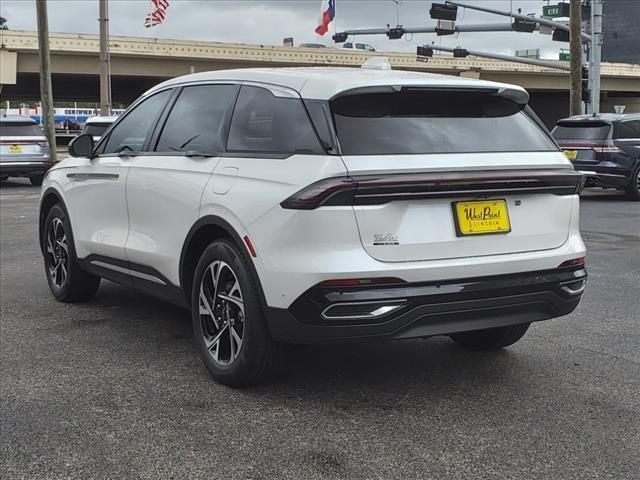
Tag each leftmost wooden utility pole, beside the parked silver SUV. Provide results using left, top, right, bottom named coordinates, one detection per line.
left=36, top=0, right=57, bottom=162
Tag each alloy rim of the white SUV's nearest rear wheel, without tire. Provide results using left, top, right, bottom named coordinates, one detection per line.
left=199, top=260, right=245, bottom=365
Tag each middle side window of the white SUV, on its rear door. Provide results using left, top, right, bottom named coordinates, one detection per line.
left=156, top=85, right=238, bottom=153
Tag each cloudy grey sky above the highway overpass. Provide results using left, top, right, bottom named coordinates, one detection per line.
left=0, top=0, right=569, bottom=59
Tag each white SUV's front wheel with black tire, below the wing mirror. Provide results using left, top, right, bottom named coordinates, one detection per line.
left=42, top=204, right=100, bottom=302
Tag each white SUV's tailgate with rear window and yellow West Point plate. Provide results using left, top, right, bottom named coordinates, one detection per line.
left=331, top=90, right=577, bottom=262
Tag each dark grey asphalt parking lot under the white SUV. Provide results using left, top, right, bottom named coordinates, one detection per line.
left=0, top=179, right=640, bottom=479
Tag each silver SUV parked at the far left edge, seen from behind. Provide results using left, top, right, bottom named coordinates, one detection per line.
left=0, top=115, right=53, bottom=185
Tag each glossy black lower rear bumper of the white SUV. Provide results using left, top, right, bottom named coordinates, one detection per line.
left=267, top=267, right=587, bottom=343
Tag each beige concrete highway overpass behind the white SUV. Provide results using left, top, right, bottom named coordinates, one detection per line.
left=0, top=30, right=640, bottom=123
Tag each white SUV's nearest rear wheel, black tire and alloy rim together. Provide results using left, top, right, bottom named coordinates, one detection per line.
left=191, top=240, right=287, bottom=387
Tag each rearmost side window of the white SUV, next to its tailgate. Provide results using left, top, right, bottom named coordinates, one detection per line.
left=227, top=86, right=324, bottom=154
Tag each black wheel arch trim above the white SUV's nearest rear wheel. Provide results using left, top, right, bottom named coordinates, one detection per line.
left=179, top=215, right=267, bottom=307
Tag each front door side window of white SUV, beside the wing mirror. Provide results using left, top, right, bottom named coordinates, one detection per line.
left=99, top=90, right=171, bottom=153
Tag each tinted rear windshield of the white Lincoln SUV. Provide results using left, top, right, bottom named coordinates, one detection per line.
left=331, top=90, right=557, bottom=155
